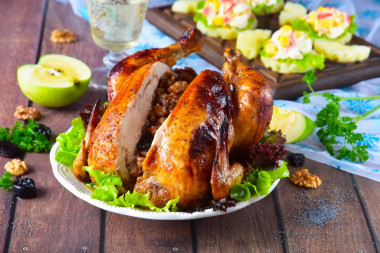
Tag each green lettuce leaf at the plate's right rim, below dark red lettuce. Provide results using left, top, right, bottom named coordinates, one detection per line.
left=230, top=162, right=289, bottom=201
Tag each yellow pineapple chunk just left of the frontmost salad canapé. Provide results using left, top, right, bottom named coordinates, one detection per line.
left=236, top=29, right=272, bottom=60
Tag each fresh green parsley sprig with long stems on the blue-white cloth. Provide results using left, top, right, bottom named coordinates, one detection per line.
left=302, top=70, right=380, bottom=162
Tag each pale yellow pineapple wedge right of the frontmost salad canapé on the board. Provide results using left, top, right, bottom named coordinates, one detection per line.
left=314, top=39, right=371, bottom=63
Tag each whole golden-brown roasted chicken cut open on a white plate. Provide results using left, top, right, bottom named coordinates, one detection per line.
left=76, top=29, right=273, bottom=209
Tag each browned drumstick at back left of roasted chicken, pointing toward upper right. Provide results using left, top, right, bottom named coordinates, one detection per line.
left=107, top=28, right=203, bottom=102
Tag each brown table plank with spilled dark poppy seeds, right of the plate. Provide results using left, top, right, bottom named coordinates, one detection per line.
left=276, top=160, right=379, bottom=253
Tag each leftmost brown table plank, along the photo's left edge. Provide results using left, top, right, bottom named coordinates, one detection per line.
left=0, top=1, right=44, bottom=248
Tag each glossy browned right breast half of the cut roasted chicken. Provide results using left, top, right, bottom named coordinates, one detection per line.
left=135, top=70, right=234, bottom=209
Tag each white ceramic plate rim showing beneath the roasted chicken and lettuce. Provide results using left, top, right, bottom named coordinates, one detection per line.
left=50, top=142, right=280, bottom=220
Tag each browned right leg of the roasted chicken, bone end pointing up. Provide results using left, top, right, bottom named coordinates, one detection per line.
left=223, top=48, right=273, bottom=154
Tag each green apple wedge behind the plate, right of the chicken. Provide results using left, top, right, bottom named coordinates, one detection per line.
left=269, top=106, right=315, bottom=143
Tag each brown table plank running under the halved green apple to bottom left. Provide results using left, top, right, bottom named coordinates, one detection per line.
left=9, top=1, right=105, bottom=252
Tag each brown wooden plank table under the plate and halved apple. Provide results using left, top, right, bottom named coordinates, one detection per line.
left=0, top=0, right=380, bottom=252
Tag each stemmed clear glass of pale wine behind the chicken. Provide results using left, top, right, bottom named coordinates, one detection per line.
left=86, top=0, right=149, bottom=87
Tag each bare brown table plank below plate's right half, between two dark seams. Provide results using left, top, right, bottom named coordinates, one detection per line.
left=194, top=195, right=282, bottom=253
